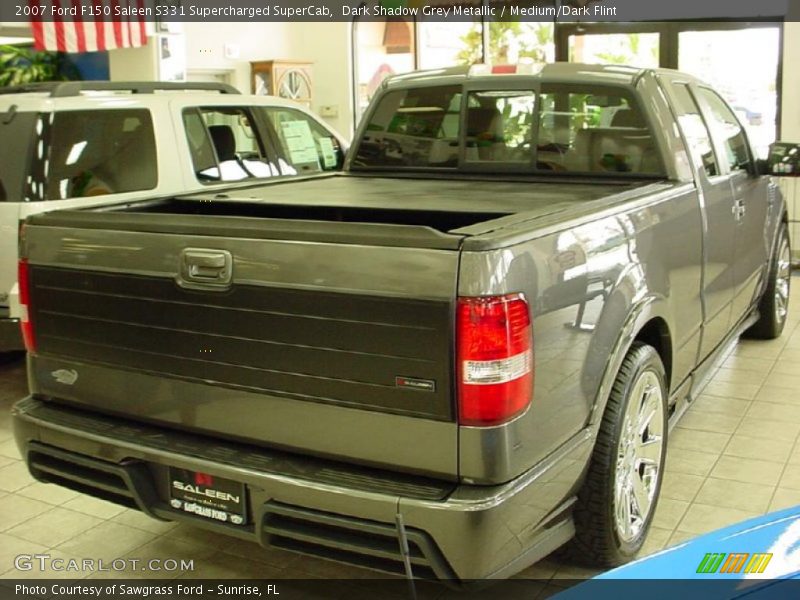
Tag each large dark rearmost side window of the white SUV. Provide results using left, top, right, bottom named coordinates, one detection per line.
left=44, top=109, right=158, bottom=200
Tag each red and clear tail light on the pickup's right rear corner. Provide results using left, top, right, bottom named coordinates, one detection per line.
left=456, top=294, right=533, bottom=427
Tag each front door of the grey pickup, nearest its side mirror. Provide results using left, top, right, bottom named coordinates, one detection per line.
left=697, top=87, right=769, bottom=325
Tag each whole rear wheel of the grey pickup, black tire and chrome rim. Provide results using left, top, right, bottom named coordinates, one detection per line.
left=567, top=342, right=667, bottom=567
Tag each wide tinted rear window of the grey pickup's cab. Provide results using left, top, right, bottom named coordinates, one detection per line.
left=353, top=84, right=664, bottom=176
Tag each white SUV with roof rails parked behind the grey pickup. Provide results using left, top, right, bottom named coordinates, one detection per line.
left=0, top=82, right=345, bottom=352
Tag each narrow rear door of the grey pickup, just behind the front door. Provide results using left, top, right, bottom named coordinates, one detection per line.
left=667, top=80, right=736, bottom=360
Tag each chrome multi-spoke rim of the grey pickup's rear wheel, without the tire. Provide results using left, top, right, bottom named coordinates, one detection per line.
left=614, top=370, right=664, bottom=543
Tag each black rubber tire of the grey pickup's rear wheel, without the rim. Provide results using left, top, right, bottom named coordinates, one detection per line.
left=564, top=342, right=668, bottom=567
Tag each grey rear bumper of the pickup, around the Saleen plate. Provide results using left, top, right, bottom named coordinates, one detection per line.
left=13, top=397, right=590, bottom=580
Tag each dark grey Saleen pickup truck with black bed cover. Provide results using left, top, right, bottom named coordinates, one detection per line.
left=13, top=64, right=791, bottom=582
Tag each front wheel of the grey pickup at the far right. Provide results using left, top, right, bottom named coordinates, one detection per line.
left=744, top=223, right=792, bottom=340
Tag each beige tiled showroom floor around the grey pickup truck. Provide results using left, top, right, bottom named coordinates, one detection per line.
left=0, top=277, right=800, bottom=580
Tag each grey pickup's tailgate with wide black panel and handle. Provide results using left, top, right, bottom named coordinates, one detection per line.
left=25, top=213, right=459, bottom=478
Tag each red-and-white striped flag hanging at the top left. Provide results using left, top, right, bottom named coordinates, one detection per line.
left=28, top=0, right=147, bottom=52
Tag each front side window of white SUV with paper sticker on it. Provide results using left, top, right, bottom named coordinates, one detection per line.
left=262, top=107, right=344, bottom=175
